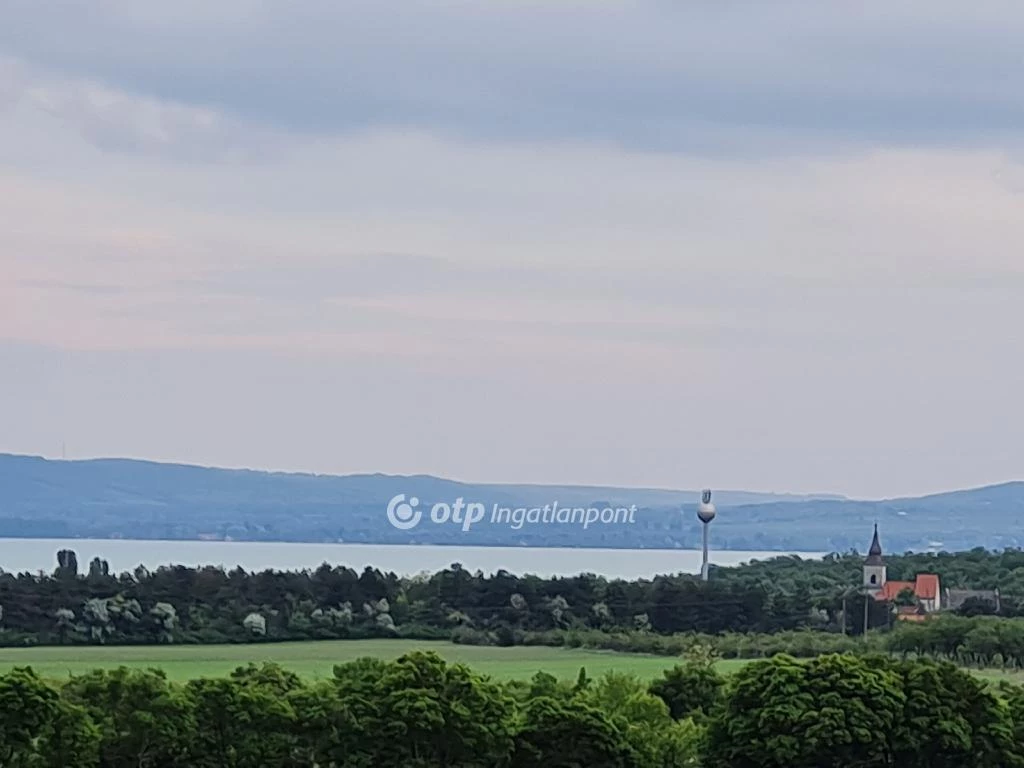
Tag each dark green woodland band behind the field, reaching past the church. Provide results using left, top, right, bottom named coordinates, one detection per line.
left=0, top=550, right=1024, bottom=645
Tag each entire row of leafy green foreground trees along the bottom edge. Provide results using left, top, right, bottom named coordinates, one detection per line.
left=0, top=652, right=1024, bottom=768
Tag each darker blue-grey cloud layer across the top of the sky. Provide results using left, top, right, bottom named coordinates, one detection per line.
left=6, top=0, right=1024, bottom=154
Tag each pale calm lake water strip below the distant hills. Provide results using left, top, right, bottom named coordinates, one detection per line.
left=0, top=539, right=824, bottom=579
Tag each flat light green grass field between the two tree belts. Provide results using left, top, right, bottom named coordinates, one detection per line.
left=0, top=640, right=742, bottom=680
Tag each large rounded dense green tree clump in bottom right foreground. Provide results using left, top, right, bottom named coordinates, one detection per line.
left=706, top=655, right=1024, bottom=768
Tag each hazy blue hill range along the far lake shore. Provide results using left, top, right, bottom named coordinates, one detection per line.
left=0, top=454, right=1024, bottom=552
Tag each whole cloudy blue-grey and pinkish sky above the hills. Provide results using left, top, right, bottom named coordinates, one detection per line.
left=0, top=0, right=1024, bottom=498
